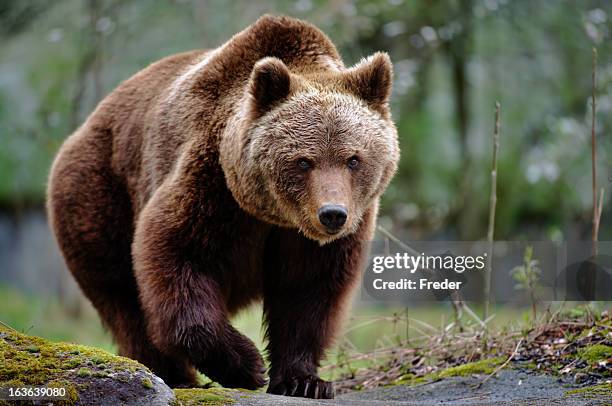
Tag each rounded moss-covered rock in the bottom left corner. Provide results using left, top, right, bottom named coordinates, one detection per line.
left=0, top=326, right=174, bottom=405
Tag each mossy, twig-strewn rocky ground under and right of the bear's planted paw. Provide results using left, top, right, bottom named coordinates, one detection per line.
left=176, top=308, right=612, bottom=406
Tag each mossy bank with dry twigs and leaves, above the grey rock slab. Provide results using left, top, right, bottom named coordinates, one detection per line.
left=327, top=308, right=612, bottom=393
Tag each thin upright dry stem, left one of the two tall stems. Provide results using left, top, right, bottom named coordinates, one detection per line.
left=482, top=102, right=501, bottom=319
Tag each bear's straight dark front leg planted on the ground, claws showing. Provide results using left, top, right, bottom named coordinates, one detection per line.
left=264, top=230, right=367, bottom=398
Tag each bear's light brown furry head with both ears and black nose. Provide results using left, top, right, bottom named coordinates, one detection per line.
left=221, top=53, right=399, bottom=243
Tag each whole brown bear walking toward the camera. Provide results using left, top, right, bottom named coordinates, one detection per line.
left=48, top=16, right=399, bottom=398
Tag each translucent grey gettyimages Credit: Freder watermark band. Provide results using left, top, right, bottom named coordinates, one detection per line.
left=362, top=240, right=612, bottom=302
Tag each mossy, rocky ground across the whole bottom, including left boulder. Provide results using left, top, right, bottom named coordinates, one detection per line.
left=0, top=311, right=612, bottom=406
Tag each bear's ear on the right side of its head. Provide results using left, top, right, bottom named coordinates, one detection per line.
left=344, top=52, right=393, bottom=116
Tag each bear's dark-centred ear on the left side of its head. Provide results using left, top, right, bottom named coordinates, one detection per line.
left=249, top=57, right=291, bottom=117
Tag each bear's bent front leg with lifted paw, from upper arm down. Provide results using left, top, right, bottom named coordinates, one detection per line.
left=133, top=185, right=265, bottom=389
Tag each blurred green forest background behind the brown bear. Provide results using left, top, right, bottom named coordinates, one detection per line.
left=0, top=0, right=612, bottom=356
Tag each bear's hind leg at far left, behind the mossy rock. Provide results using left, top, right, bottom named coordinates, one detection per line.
left=48, top=130, right=197, bottom=386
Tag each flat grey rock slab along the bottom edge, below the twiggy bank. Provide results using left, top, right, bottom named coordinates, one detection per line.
left=190, top=368, right=612, bottom=406
